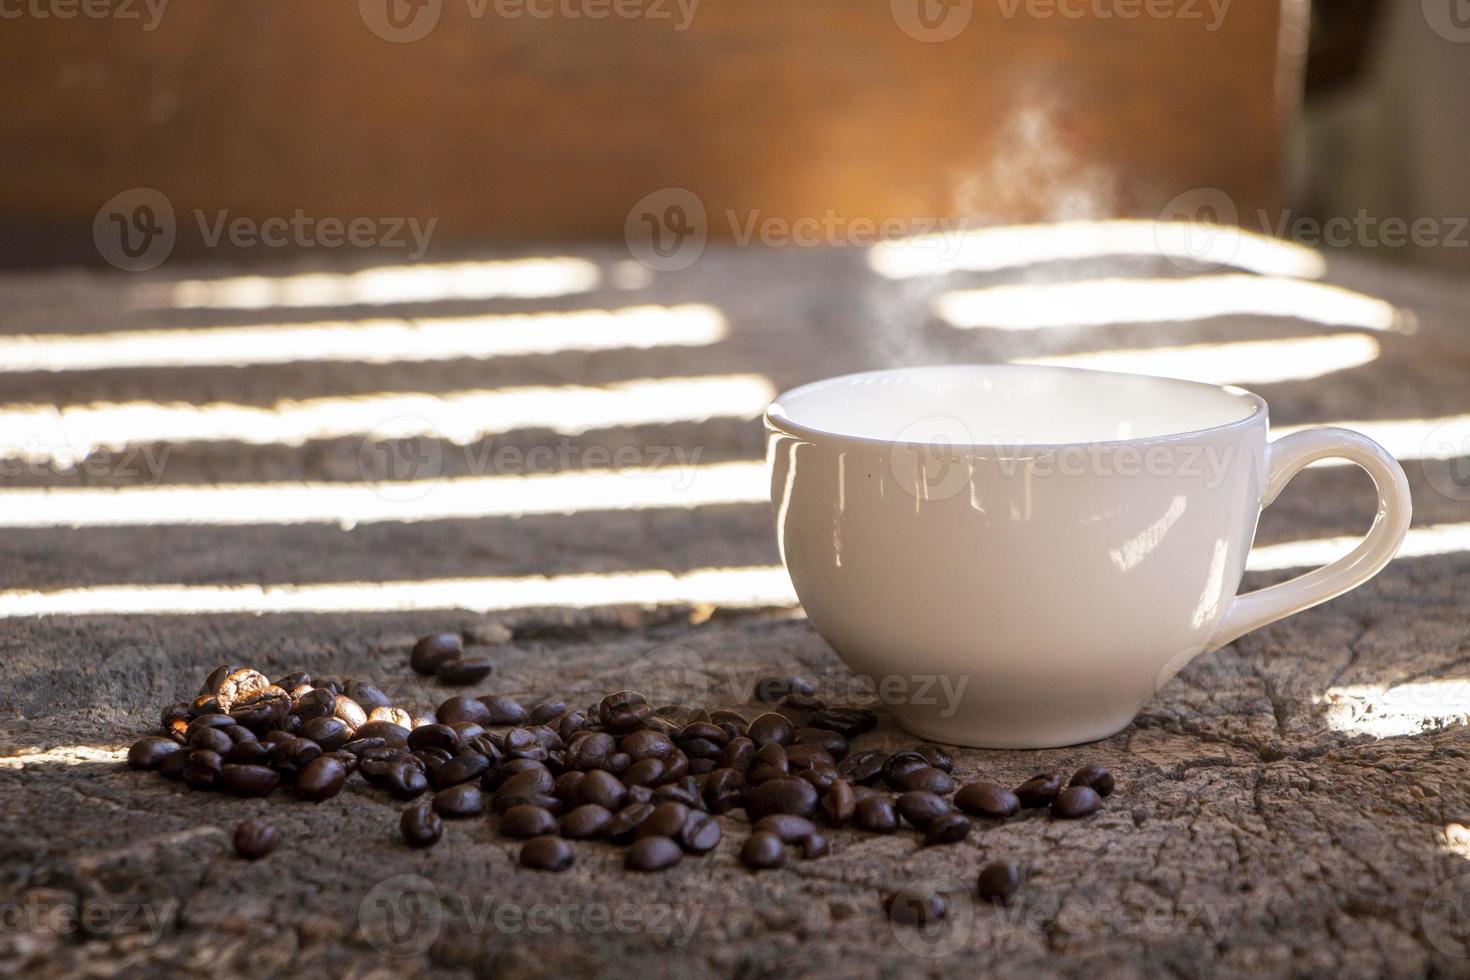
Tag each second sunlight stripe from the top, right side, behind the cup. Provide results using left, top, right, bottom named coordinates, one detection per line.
left=935, top=275, right=1407, bottom=331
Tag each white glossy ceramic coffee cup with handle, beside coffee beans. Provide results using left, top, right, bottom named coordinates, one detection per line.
left=766, top=366, right=1410, bottom=748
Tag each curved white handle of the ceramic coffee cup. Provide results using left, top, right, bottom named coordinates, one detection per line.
left=1210, top=428, right=1413, bottom=648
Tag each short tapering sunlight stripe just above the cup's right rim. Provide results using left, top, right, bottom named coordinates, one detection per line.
left=1016, top=334, right=1382, bottom=385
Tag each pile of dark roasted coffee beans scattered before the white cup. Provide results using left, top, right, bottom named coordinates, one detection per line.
left=128, top=652, right=1113, bottom=918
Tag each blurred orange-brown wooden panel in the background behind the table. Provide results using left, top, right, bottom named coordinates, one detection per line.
left=0, top=0, right=1299, bottom=264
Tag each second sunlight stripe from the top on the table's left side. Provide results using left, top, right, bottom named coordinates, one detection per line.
left=0, top=304, right=729, bottom=373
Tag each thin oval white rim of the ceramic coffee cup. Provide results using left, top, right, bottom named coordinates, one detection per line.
left=761, top=363, right=1270, bottom=453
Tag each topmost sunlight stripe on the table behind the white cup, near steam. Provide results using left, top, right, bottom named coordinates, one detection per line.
left=867, top=219, right=1327, bottom=279
